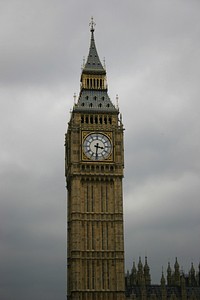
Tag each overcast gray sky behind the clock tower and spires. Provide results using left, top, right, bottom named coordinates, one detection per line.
left=0, top=0, right=200, bottom=300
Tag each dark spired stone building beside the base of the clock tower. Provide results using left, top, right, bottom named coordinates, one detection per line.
left=125, top=258, right=200, bottom=300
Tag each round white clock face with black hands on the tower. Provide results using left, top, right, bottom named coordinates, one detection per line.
left=83, top=132, right=112, bottom=160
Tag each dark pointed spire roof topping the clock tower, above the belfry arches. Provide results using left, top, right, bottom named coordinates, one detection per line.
left=82, top=18, right=106, bottom=74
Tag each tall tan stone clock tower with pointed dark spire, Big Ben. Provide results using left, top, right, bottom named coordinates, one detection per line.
left=65, top=19, right=125, bottom=300
